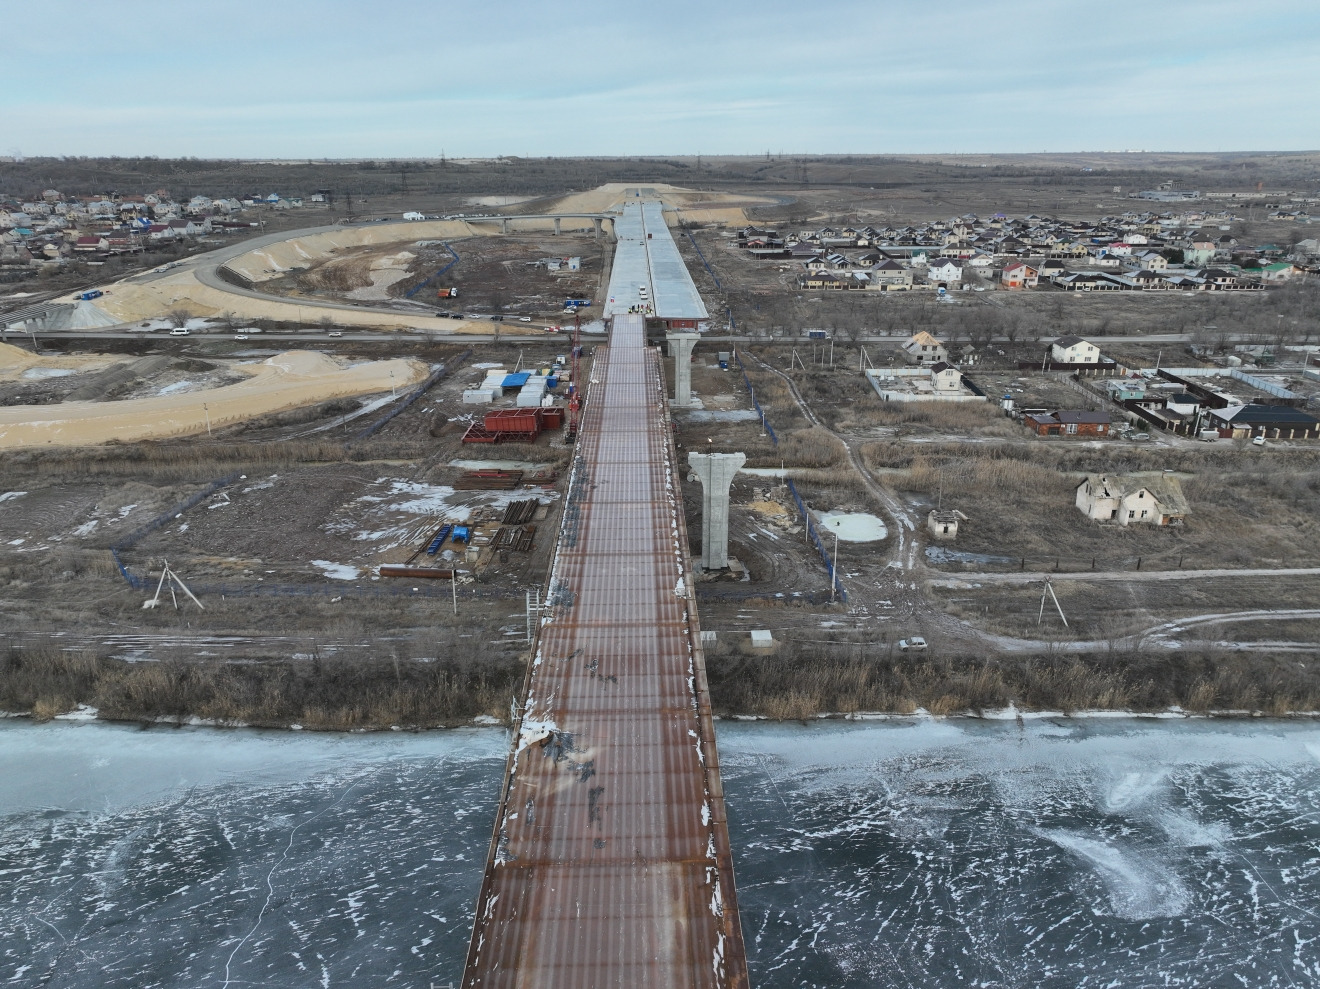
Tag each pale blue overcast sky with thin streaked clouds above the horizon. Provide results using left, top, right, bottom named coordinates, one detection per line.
left=10, top=0, right=1320, bottom=157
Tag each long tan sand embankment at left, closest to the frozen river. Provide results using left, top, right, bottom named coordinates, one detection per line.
left=0, top=347, right=428, bottom=449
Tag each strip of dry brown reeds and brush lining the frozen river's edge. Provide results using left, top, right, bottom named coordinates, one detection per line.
left=0, top=643, right=1320, bottom=732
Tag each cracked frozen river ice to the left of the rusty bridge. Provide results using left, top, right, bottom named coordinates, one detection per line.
left=0, top=722, right=507, bottom=989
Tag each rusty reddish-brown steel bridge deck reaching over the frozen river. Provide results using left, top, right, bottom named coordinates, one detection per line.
left=463, top=316, right=747, bottom=989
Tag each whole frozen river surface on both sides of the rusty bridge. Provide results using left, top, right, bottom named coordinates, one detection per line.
left=0, top=720, right=1320, bottom=989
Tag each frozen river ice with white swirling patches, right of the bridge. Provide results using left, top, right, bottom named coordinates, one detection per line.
left=719, top=718, right=1320, bottom=989
